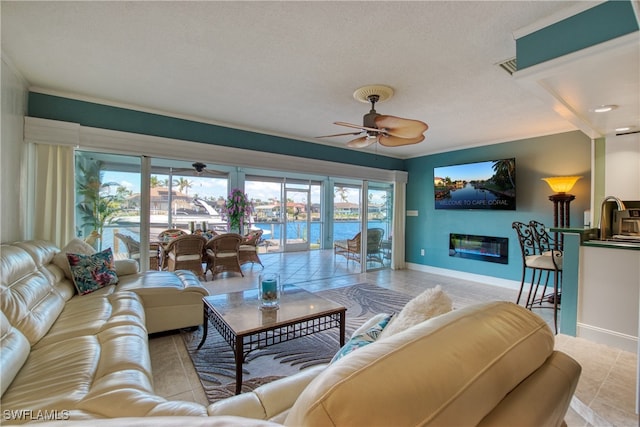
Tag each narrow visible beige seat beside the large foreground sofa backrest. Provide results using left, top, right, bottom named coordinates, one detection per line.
left=207, top=364, right=326, bottom=421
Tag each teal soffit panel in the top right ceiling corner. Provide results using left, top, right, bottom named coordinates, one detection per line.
left=516, top=0, right=638, bottom=70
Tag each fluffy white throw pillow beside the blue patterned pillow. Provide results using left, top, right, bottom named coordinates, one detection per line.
left=378, top=285, right=453, bottom=339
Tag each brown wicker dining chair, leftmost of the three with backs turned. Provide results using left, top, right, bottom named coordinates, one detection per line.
left=162, top=234, right=207, bottom=277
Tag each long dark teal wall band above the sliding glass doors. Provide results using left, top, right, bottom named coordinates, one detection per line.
left=28, top=92, right=404, bottom=170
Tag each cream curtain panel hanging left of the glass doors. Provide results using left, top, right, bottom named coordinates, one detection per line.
left=33, top=144, right=75, bottom=247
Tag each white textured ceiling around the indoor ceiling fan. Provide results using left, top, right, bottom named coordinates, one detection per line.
left=1, top=1, right=638, bottom=158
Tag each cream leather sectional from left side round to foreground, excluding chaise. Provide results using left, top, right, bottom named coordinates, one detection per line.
left=0, top=242, right=580, bottom=426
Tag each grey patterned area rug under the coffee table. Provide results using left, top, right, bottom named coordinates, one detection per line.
left=182, top=283, right=411, bottom=403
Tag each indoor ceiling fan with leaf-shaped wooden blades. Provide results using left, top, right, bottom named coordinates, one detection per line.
left=317, top=85, right=429, bottom=148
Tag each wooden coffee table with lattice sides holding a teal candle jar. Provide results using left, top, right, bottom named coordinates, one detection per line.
left=198, top=285, right=347, bottom=394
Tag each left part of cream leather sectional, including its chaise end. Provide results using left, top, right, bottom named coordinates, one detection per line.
left=0, top=241, right=207, bottom=422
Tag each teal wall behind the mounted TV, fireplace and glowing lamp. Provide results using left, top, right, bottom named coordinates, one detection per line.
left=405, top=131, right=591, bottom=281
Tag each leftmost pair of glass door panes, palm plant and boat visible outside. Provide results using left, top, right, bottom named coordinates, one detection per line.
left=76, top=151, right=228, bottom=269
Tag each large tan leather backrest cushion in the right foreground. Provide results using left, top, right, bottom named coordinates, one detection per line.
left=285, top=302, right=554, bottom=426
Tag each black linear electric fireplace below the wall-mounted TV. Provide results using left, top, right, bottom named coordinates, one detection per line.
left=449, top=233, right=509, bottom=264
